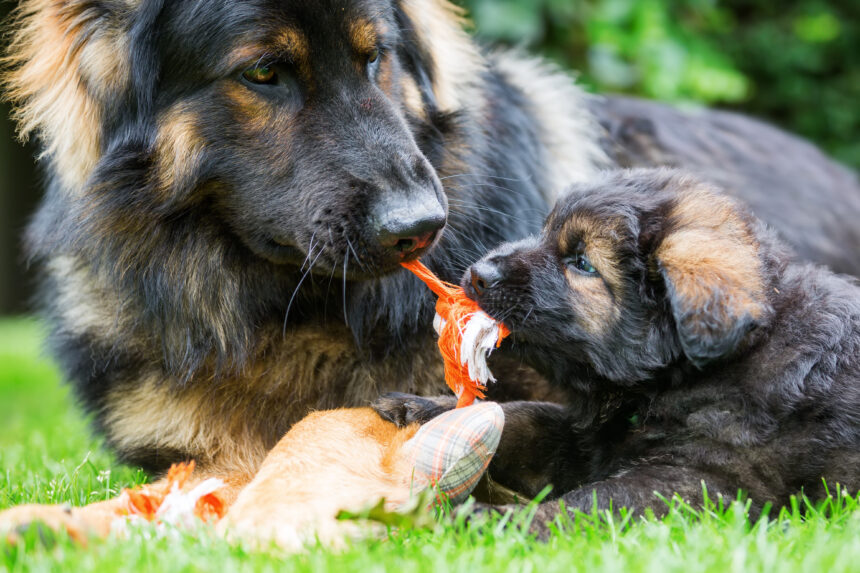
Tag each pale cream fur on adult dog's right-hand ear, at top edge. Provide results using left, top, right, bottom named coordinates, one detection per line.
left=403, top=0, right=484, bottom=111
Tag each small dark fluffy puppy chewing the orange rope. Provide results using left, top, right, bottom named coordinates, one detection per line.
left=377, top=170, right=860, bottom=524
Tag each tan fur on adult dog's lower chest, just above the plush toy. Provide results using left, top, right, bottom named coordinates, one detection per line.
left=104, top=325, right=444, bottom=478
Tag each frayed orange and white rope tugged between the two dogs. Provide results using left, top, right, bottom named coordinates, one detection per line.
left=401, top=261, right=511, bottom=408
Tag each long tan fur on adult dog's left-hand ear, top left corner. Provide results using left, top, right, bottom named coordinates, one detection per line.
left=3, top=0, right=128, bottom=192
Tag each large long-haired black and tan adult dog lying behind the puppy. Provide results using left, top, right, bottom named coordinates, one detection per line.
left=5, top=0, right=860, bottom=504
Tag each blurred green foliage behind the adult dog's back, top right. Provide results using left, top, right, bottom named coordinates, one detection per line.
left=460, top=0, right=860, bottom=167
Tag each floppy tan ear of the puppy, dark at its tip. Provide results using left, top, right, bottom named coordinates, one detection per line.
left=656, top=184, right=770, bottom=368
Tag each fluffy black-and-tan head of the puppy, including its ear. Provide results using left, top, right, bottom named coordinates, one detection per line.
left=463, top=170, right=769, bottom=384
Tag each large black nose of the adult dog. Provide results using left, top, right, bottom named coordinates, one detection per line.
left=377, top=199, right=446, bottom=258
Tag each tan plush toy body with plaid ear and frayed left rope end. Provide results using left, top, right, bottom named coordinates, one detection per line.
left=110, top=402, right=505, bottom=532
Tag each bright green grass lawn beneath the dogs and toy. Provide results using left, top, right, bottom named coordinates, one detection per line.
left=0, top=320, right=860, bottom=573
